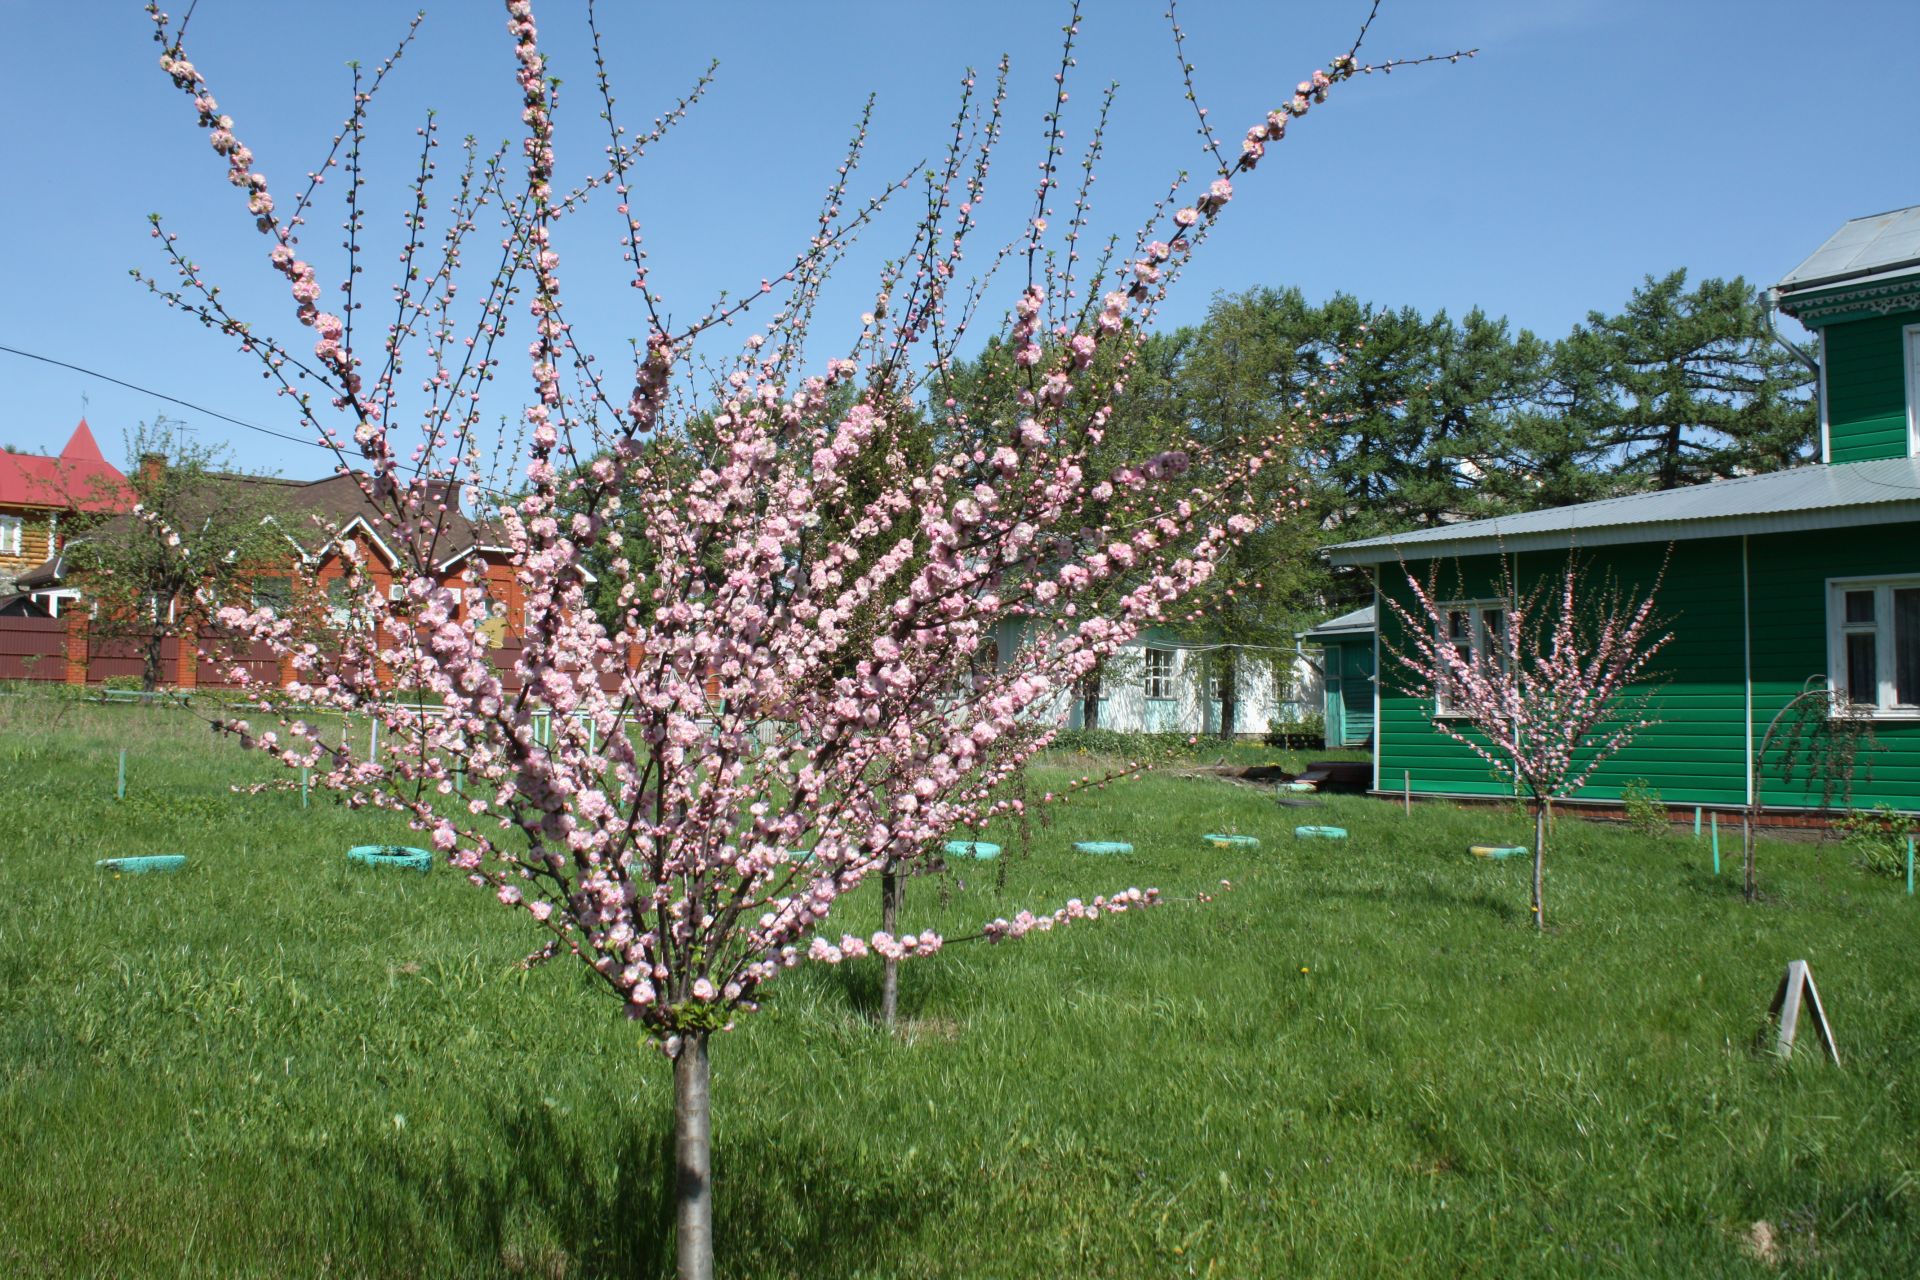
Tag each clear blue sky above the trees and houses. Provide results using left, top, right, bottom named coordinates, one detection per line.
left=0, top=0, right=1920, bottom=476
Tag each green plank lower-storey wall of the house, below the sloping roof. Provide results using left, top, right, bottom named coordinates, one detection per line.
left=1375, top=524, right=1920, bottom=810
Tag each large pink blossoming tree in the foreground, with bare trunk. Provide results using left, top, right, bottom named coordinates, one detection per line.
left=148, top=0, right=1466, bottom=1276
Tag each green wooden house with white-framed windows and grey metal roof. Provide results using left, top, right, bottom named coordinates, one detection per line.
left=1332, top=205, right=1920, bottom=812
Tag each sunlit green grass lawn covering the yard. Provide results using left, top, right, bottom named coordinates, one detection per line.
left=0, top=697, right=1920, bottom=1278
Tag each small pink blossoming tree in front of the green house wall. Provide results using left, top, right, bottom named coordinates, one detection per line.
left=1382, top=555, right=1672, bottom=929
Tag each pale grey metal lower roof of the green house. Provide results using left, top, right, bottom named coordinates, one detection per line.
left=1329, top=459, right=1920, bottom=564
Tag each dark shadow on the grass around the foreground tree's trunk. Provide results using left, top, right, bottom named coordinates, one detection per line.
left=359, top=1102, right=950, bottom=1276
